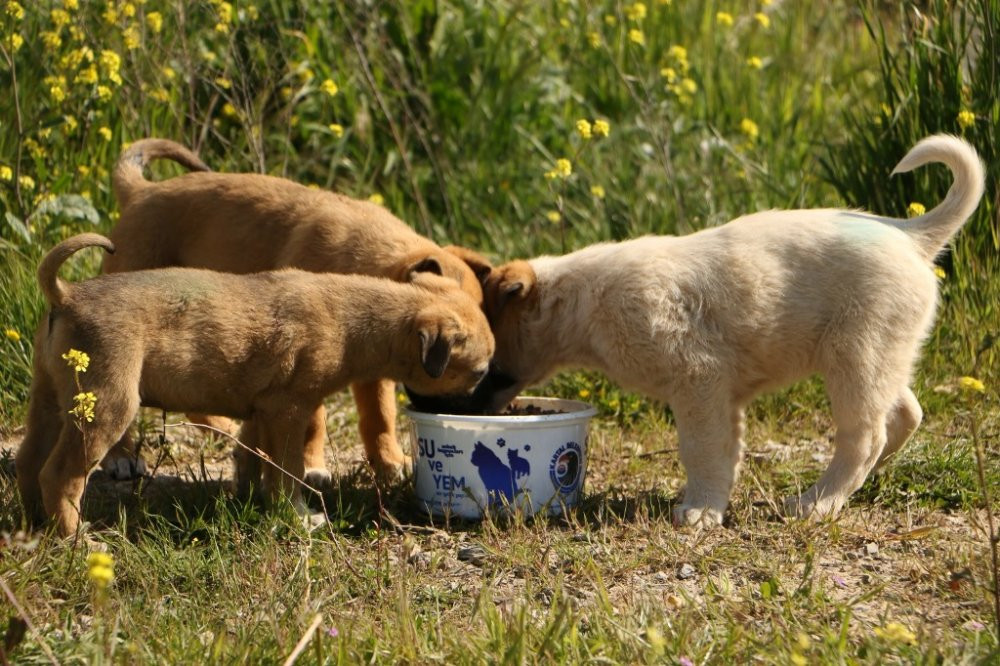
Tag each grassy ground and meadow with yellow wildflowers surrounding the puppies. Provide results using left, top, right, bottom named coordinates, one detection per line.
left=0, top=0, right=1000, bottom=664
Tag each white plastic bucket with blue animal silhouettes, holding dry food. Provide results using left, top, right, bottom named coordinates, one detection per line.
left=403, top=397, right=597, bottom=519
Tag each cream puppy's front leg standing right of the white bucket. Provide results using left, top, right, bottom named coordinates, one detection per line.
left=671, top=390, right=744, bottom=527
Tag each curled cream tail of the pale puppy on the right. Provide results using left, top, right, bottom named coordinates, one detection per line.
left=892, top=134, right=983, bottom=260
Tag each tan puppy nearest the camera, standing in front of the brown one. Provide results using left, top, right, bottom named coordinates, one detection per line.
left=16, top=234, right=493, bottom=535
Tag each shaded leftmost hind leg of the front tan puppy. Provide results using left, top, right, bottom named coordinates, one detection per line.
left=14, top=366, right=63, bottom=524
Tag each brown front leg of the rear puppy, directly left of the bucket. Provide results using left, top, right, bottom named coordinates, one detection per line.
left=351, top=380, right=410, bottom=481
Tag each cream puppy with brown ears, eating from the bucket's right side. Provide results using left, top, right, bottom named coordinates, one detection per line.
left=480, top=135, right=983, bottom=524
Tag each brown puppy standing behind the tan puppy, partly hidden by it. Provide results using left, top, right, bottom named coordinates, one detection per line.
left=104, top=139, right=490, bottom=485
